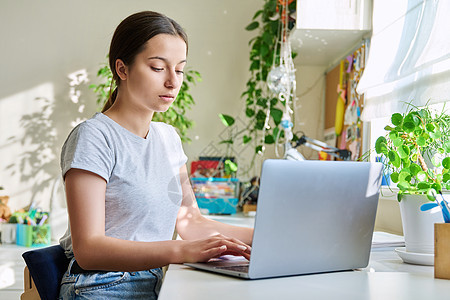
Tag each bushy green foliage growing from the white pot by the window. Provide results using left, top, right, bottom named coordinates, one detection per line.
left=375, top=106, right=450, bottom=201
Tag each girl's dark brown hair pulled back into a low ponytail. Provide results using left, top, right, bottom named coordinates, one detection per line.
left=102, top=11, right=188, bottom=112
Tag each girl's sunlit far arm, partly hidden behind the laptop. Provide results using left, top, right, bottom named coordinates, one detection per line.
left=177, top=165, right=253, bottom=246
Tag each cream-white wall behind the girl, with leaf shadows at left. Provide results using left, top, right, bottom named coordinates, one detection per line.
left=0, top=0, right=324, bottom=213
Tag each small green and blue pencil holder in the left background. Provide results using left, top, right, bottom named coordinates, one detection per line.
left=16, top=224, right=51, bottom=247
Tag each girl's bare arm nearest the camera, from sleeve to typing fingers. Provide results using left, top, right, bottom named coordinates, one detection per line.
left=65, top=169, right=250, bottom=271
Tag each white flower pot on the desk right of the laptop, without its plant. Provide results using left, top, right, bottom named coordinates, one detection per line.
left=400, top=195, right=444, bottom=254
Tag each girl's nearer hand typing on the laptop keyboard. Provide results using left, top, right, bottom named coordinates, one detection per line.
left=181, top=234, right=251, bottom=263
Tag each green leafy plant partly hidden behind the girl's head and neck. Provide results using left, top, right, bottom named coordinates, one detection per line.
left=89, top=64, right=202, bottom=142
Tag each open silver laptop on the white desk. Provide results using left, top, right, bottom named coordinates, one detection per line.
left=186, top=160, right=382, bottom=279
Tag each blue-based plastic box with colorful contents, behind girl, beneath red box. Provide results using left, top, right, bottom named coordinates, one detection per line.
left=191, top=177, right=239, bottom=215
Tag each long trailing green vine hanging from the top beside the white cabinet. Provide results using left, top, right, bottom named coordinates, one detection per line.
left=219, top=0, right=297, bottom=155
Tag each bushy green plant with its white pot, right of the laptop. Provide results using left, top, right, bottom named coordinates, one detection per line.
left=375, top=104, right=450, bottom=255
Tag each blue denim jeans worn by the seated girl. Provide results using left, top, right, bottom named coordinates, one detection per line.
left=59, top=259, right=163, bottom=300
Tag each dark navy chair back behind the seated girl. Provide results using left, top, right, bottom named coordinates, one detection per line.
left=22, top=245, right=70, bottom=300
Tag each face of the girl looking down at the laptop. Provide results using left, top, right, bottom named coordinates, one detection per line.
left=121, top=34, right=186, bottom=112
